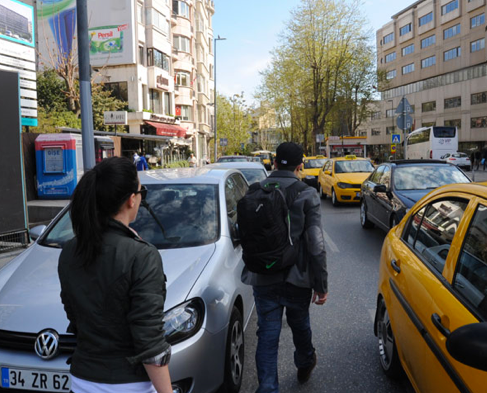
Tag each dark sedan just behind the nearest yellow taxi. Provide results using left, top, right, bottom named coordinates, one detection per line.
left=360, top=160, right=471, bottom=231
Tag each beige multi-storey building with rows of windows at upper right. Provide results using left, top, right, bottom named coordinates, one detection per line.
left=370, top=0, right=487, bottom=155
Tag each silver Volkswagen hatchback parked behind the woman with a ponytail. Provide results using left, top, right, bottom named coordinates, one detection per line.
left=0, top=167, right=254, bottom=393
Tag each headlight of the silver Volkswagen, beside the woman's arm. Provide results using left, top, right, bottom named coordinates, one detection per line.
left=163, top=299, right=205, bottom=345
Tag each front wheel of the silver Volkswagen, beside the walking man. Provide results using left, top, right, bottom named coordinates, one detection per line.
left=219, top=306, right=245, bottom=393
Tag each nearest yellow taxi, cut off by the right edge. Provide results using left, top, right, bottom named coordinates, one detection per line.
left=374, top=182, right=487, bottom=393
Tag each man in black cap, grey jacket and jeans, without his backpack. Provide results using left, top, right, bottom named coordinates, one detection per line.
left=239, top=142, right=328, bottom=393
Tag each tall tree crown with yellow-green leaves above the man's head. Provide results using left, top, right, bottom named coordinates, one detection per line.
left=257, top=0, right=377, bottom=153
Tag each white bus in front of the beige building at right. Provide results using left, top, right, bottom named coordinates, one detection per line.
left=406, top=126, right=458, bottom=160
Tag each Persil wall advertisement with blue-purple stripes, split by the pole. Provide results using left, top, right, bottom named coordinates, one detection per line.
left=37, top=0, right=136, bottom=67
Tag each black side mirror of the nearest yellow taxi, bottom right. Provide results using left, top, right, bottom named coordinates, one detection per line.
left=446, top=322, right=487, bottom=371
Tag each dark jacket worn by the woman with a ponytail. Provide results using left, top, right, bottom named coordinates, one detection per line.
left=58, top=220, right=170, bottom=383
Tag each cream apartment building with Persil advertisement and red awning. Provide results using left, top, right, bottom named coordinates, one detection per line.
left=37, top=0, right=215, bottom=164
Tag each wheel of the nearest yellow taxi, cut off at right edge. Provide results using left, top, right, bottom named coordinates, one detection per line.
left=375, top=299, right=404, bottom=379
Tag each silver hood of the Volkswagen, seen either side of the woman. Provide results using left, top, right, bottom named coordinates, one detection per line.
left=0, top=244, right=216, bottom=333
